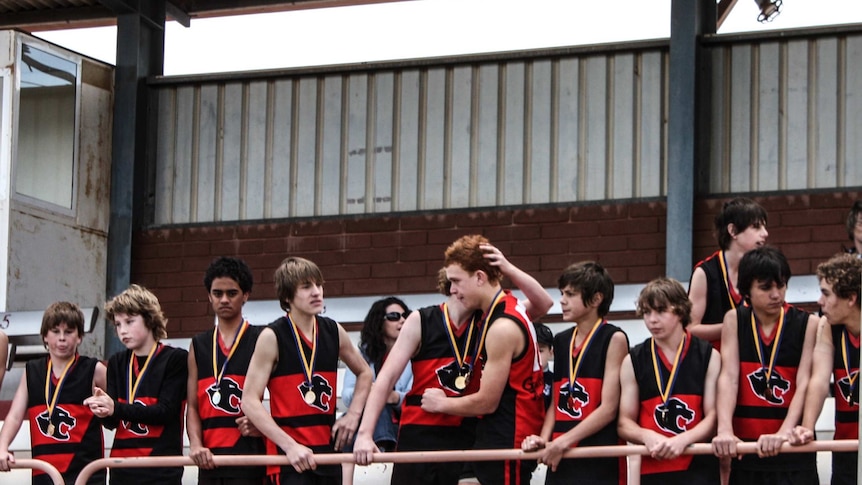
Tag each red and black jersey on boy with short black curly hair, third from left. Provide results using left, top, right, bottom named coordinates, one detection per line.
left=192, top=325, right=266, bottom=478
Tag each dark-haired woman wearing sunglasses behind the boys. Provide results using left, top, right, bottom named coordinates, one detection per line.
left=341, top=296, right=413, bottom=485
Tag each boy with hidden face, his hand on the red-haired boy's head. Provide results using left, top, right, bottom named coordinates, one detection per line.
left=354, top=244, right=553, bottom=485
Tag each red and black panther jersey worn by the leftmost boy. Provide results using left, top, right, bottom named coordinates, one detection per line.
left=26, top=356, right=105, bottom=484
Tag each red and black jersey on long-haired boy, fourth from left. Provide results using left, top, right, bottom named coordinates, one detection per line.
left=266, top=315, right=341, bottom=475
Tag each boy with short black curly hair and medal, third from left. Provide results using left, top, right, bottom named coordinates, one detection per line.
left=186, top=257, right=266, bottom=485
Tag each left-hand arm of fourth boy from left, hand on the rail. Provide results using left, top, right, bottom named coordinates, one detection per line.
left=242, top=328, right=317, bottom=473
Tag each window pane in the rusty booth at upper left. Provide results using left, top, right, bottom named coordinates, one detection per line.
left=15, top=44, right=78, bottom=209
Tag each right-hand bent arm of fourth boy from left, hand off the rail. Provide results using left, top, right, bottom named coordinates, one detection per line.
left=332, top=324, right=374, bottom=451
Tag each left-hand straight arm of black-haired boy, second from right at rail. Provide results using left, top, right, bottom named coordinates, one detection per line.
left=712, top=310, right=741, bottom=457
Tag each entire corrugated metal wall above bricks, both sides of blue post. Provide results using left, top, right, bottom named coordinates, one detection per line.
left=154, top=29, right=862, bottom=225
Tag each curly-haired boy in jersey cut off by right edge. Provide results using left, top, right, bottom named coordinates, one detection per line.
left=792, top=254, right=862, bottom=485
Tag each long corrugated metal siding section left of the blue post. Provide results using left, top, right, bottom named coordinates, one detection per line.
left=154, top=48, right=667, bottom=225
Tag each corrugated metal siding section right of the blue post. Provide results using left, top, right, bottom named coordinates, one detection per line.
left=709, top=34, right=862, bottom=193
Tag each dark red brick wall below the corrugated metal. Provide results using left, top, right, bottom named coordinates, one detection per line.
left=132, top=192, right=862, bottom=337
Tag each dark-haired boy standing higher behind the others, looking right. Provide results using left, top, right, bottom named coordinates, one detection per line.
left=688, top=197, right=769, bottom=350
